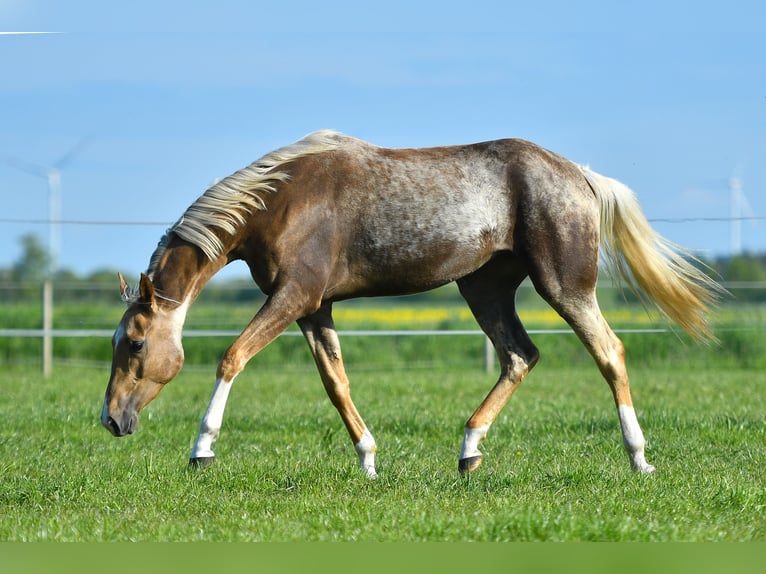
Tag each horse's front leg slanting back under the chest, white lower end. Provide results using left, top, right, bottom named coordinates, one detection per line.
left=298, top=304, right=377, bottom=478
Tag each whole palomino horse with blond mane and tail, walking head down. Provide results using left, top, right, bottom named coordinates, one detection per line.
left=101, top=131, right=718, bottom=478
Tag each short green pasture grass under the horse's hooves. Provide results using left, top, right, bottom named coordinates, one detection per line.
left=0, top=356, right=766, bottom=541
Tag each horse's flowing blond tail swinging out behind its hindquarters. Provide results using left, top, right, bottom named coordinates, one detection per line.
left=581, top=164, right=725, bottom=341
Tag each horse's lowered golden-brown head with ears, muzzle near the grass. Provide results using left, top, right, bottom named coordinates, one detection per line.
left=101, top=274, right=184, bottom=436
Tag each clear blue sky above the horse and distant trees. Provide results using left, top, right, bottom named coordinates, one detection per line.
left=0, top=0, right=766, bottom=277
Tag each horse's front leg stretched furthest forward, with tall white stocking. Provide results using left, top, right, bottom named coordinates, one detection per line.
left=189, top=293, right=314, bottom=467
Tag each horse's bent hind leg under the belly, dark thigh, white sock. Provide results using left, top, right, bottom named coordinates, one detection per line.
left=458, top=260, right=540, bottom=476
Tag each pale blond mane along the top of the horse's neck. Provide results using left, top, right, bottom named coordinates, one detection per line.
left=149, top=130, right=340, bottom=276
